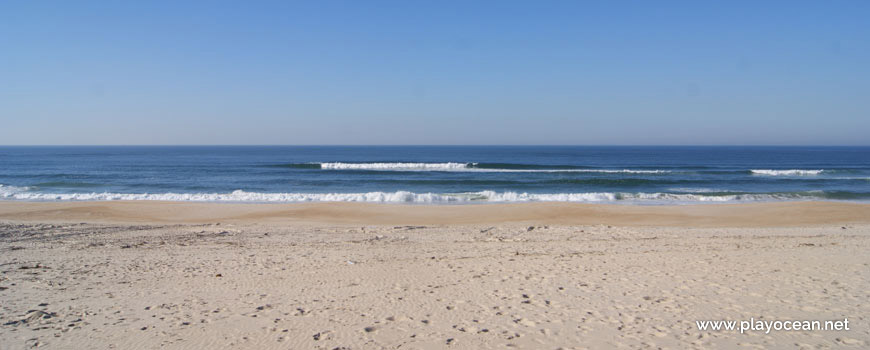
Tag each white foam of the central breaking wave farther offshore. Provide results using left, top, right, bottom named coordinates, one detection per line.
left=319, top=162, right=670, bottom=174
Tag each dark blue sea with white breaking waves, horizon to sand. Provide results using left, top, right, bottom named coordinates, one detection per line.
left=0, top=146, right=870, bottom=204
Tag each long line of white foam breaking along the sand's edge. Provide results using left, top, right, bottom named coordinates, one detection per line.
left=0, top=185, right=815, bottom=204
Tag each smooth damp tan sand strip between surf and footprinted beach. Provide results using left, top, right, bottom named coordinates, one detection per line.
left=0, top=201, right=870, bottom=227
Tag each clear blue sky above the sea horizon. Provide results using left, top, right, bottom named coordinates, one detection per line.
left=0, top=0, right=870, bottom=145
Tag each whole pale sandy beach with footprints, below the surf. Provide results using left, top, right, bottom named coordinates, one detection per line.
left=0, top=202, right=870, bottom=350
